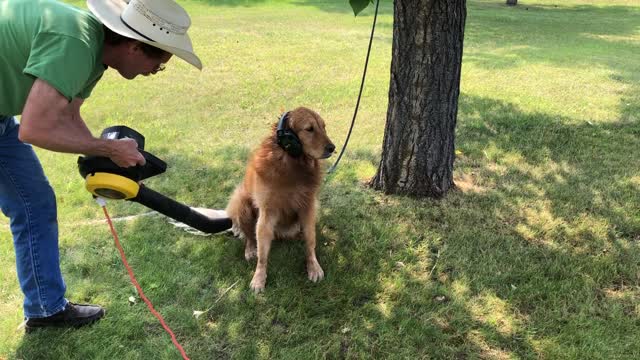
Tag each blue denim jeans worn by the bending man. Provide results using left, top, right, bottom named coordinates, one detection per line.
left=0, top=115, right=67, bottom=318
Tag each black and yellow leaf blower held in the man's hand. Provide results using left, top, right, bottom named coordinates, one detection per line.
left=78, top=126, right=232, bottom=234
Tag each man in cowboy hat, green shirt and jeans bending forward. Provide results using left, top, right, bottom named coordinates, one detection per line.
left=0, top=0, right=202, bottom=331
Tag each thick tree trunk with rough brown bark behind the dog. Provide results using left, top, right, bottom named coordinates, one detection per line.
left=370, top=0, right=467, bottom=198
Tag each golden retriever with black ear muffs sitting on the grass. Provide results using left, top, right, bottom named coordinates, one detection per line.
left=226, top=107, right=335, bottom=293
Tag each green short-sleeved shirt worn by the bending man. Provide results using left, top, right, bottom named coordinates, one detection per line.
left=0, top=0, right=106, bottom=115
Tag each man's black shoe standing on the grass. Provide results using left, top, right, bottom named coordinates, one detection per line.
left=25, top=302, right=104, bottom=333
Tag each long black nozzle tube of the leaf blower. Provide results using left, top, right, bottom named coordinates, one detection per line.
left=128, top=184, right=232, bottom=234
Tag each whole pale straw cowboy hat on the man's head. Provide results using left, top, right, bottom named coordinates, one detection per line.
left=87, top=0, right=202, bottom=69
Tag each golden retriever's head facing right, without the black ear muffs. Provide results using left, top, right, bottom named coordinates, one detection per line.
left=287, top=107, right=336, bottom=159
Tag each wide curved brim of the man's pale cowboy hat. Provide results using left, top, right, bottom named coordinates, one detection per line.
left=87, top=0, right=202, bottom=70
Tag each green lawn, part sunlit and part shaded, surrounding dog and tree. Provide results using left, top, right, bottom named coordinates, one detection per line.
left=0, top=0, right=640, bottom=359
